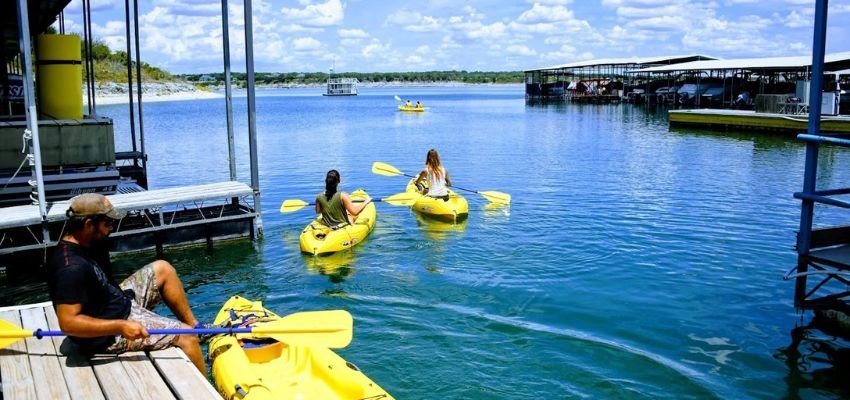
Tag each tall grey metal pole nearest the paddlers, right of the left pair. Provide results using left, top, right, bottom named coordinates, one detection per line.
left=242, top=0, right=263, bottom=237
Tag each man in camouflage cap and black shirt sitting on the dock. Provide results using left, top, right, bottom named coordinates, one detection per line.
left=47, top=193, right=206, bottom=375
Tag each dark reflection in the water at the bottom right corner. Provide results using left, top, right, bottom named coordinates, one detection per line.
left=776, top=318, right=850, bottom=399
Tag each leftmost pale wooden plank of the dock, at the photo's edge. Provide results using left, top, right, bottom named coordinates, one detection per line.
left=0, top=310, right=36, bottom=400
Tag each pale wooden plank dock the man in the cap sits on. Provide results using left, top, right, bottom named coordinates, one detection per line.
left=0, top=302, right=221, bottom=400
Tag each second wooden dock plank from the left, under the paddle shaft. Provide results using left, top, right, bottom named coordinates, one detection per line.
left=21, top=308, right=71, bottom=400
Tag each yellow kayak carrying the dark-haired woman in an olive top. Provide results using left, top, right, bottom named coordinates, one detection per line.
left=300, top=189, right=377, bottom=255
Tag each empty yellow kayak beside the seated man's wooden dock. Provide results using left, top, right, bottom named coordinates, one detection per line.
left=209, top=296, right=393, bottom=400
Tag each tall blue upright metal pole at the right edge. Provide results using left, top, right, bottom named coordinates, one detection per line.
left=794, top=0, right=829, bottom=306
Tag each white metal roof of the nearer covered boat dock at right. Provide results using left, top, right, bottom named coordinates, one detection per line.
left=629, top=52, right=850, bottom=73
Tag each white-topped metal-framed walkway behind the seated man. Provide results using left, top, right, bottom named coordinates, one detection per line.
left=0, top=181, right=257, bottom=256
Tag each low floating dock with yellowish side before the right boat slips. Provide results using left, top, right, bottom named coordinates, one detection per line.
left=669, top=109, right=850, bottom=135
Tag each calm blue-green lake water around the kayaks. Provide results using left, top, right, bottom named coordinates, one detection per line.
left=1, top=86, right=850, bottom=399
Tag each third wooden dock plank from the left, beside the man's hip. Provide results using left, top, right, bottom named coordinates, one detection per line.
left=44, top=306, right=104, bottom=400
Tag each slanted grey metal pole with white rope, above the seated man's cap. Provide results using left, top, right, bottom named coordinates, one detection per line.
left=18, top=0, right=50, bottom=219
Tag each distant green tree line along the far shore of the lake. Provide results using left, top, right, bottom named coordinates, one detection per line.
left=177, top=71, right=525, bottom=86
